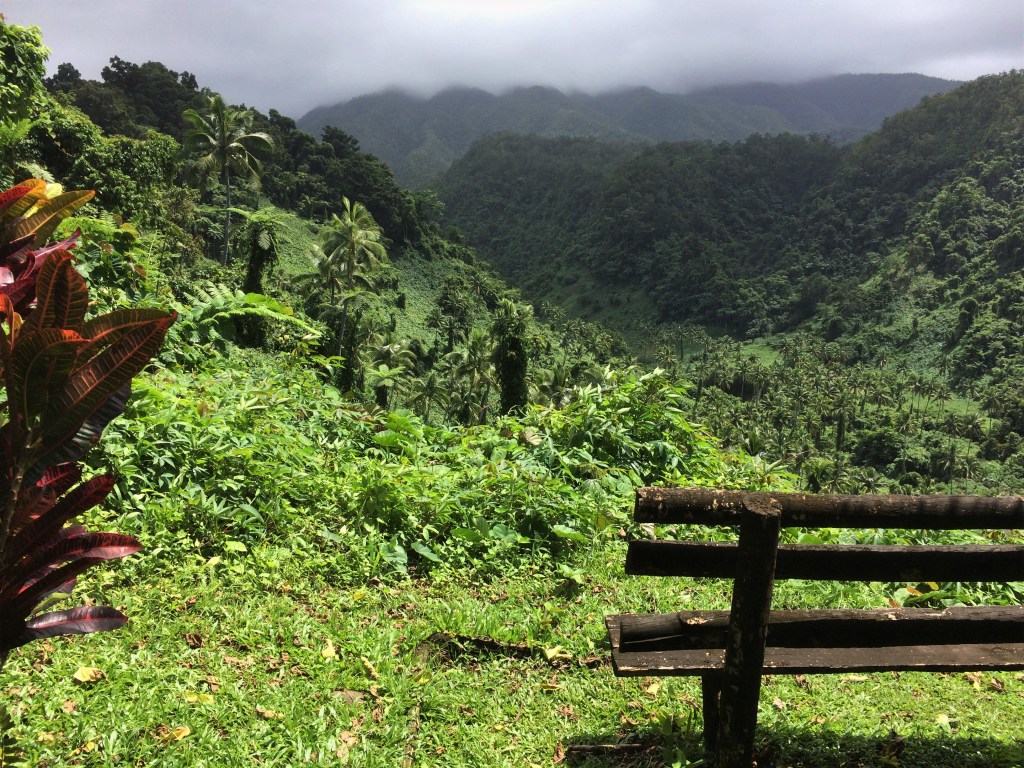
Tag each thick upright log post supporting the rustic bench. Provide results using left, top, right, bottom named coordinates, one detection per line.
left=706, top=497, right=781, bottom=768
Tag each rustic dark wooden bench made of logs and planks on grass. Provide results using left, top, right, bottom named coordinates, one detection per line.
left=605, top=487, right=1024, bottom=768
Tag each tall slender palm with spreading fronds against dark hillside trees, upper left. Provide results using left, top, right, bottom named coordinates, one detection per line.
left=181, top=94, right=273, bottom=264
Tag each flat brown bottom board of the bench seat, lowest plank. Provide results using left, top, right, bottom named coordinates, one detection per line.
left=606, top=616, right=1024, bottom=677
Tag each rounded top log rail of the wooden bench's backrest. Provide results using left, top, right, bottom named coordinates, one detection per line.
left=635, top=487, right=1024, bottom=529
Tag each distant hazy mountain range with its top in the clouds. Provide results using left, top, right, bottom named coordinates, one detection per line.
left=298, top=74, right=957, bottom=187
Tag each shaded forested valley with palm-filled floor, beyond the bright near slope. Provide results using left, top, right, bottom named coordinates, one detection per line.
left=439, top=73, right=1024, bottom=493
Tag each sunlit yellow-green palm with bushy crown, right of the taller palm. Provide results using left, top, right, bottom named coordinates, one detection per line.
left=314, top=198, right=387, bottom=355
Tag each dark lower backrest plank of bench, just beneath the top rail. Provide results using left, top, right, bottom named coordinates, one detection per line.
left=626, top=540, right=1024, bottom=583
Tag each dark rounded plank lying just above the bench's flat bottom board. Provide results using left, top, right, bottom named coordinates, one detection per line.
left=617, top=606, right=1024, bottom=653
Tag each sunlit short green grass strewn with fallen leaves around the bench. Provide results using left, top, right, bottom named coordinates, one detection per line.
left=3, top=542, right=1024, bottom=768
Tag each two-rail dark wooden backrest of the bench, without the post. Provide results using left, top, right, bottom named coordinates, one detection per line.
left=626, top=487, right=1024, bottom=583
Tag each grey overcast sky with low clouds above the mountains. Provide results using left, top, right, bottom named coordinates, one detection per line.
left=0, top=0, right=1024, bottom=118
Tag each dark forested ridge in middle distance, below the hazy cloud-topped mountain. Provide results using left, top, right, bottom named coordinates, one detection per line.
left=438, top=73, right=1024, bottom=346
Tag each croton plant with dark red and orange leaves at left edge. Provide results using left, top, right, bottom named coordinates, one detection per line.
left=0, top=179, right=174, bottom=666
